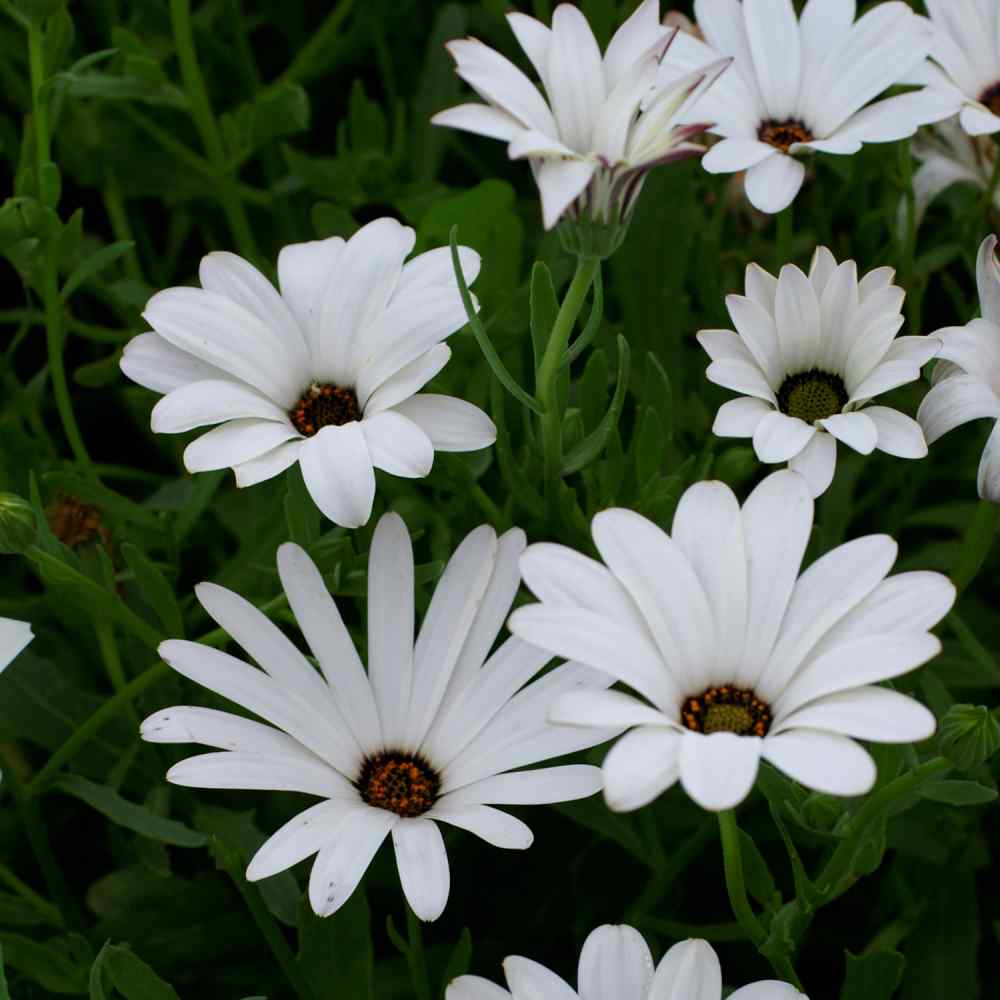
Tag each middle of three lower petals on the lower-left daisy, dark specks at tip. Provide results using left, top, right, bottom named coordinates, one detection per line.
left=309, top=805, right=401, bottom=917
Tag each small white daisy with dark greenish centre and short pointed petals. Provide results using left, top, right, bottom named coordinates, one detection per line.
left=698, top=247, right=939, bottom=497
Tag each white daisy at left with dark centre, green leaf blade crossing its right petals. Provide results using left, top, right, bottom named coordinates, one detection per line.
left=121, top=219, right=496, bottom=528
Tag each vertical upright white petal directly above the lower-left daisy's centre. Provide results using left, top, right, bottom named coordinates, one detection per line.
left=368, top=513, right=414, bottom=746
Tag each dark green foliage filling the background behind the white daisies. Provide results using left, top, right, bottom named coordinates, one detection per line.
left=0, top=0, right=1000, bottom=1000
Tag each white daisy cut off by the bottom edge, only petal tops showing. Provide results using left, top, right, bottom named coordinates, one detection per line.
left=445, top=924, right=808, bottom=1000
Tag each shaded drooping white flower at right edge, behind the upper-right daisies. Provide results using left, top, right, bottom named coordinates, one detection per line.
left=898, top=118, right=1000, bottom=231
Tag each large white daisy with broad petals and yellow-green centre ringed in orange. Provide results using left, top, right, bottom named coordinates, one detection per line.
left=510, top=471, right=955, bottom=810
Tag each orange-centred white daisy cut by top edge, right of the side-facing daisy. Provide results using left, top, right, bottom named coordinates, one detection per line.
left=665, top=0, right=951, bottom=213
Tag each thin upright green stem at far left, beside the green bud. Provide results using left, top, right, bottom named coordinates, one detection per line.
left=28, top=18, right=97, bottom=479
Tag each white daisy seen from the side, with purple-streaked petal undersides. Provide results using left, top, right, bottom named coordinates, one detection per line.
left=431, top=0, right=729, bottom=238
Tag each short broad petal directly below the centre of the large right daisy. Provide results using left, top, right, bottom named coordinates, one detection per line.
left=680, top=731, right=763, bottom=812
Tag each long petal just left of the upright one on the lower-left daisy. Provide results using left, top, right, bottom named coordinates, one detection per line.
left=278, top=542, right=382, bottom=751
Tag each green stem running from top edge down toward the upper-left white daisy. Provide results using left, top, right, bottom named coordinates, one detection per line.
left=170, top=0, right=258, bottom=261
